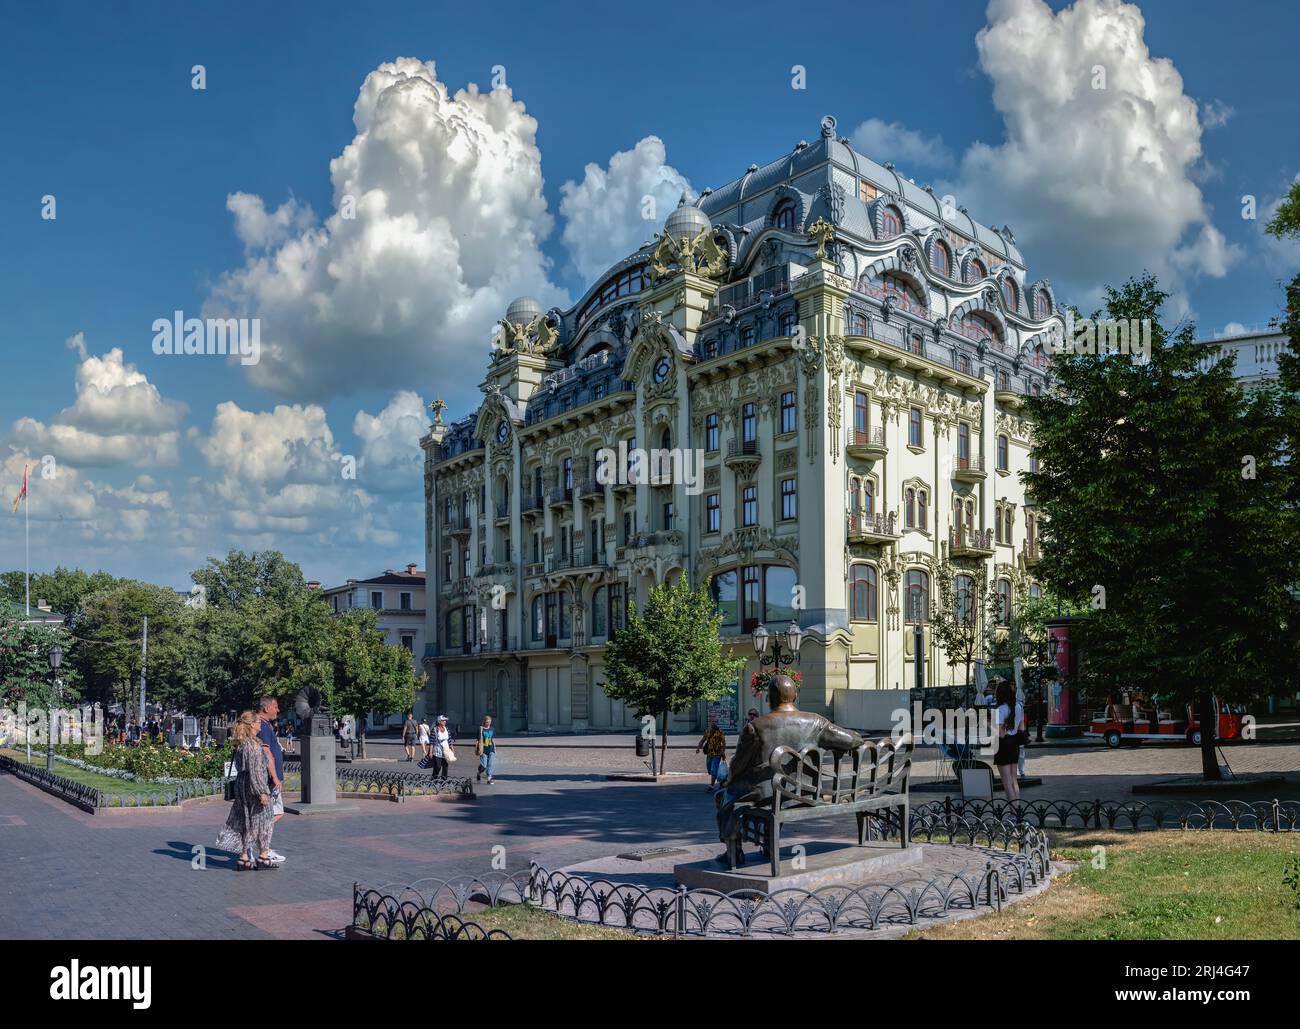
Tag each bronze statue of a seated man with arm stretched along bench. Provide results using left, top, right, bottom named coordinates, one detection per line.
left=718, top=676, right=865, bottom=865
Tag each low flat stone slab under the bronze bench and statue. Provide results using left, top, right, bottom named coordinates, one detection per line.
left=672, top=841, right=922, bottom=894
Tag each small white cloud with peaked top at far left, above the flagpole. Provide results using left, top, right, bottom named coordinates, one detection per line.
left=12, top=333, right=186, bottom=468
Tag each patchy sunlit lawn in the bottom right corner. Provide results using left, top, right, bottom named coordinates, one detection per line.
left=914, top=829, right=1300, bottom=939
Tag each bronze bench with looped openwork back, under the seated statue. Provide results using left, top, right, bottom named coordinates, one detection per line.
left=725, top=735, right=913, bottom=876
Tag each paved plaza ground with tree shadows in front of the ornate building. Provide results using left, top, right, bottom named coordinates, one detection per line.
left=0, top=738, right=1300, bottom=939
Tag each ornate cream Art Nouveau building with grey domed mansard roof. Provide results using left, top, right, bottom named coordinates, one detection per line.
left=423, top=118, right=1063, bottom=730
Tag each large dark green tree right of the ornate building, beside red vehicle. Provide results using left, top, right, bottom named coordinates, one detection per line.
left=1022, top=274, right=1300, bottom=778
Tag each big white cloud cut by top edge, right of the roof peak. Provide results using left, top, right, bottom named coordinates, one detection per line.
left=953, top=0, right=1242, bottom=297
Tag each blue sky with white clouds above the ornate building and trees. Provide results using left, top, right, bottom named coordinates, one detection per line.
left=0, top=0, right=1300, bottom=585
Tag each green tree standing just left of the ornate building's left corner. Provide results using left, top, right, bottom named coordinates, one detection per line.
left=321, top=604, right=425, bottom=757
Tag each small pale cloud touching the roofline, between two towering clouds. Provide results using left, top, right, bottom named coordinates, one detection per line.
left=560, top=135, right=690, bottom=279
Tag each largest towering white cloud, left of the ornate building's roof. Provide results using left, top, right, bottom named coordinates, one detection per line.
left=205, top=57, right=567, bottom=399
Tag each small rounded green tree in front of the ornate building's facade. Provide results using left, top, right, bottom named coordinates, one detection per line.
left=605, top=576, right=745, bottom=769
